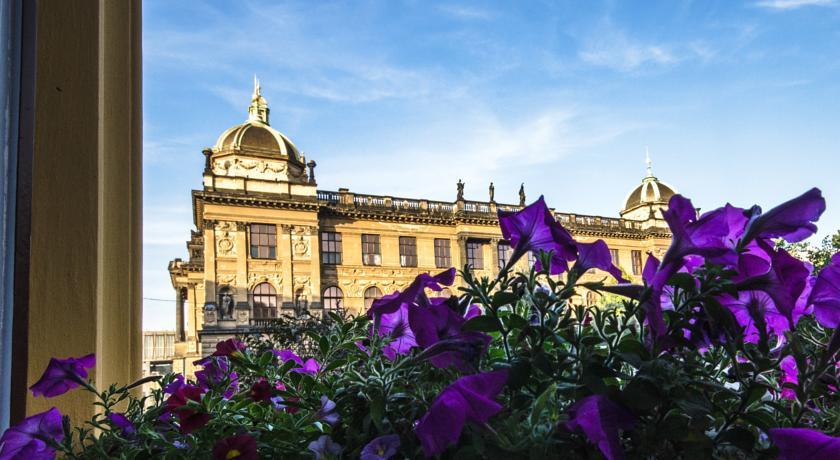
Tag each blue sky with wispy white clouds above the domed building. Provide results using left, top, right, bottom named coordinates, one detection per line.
left=143, top=0, right=840, bottom=329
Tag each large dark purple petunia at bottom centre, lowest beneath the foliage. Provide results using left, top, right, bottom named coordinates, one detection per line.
left=415, top=370, right=507, bottom=457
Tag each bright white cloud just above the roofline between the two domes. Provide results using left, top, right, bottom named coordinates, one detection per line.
left=319, top=103, right=642, bottom=202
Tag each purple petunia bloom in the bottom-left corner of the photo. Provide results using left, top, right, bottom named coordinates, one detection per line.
left=0, top=407, right=64, bottom=460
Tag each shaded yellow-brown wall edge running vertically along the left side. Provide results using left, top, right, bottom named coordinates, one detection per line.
left=20, top=0, right=142, bottom=422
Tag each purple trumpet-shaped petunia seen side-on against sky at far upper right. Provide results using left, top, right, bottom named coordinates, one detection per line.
left=741, top=188, right=825, bottom=246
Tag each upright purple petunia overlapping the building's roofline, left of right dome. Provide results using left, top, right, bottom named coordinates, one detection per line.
left=499, top=196, right=577, bottom=275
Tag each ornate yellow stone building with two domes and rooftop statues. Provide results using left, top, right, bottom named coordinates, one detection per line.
left=169, top=82, right=675, bottom=373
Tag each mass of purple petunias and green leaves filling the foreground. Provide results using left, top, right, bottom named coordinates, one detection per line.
left=0, top=189, right=840, bottom=459
